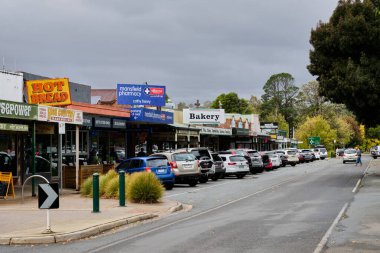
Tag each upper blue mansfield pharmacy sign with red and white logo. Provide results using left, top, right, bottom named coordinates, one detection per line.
left=116, top=84, right=166, bottom=106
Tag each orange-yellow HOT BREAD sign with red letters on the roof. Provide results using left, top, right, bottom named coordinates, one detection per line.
left=26, top=78, right=71, bottom=106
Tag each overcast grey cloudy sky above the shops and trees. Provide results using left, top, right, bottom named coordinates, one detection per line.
left=0, top=0, right=337, bottom=103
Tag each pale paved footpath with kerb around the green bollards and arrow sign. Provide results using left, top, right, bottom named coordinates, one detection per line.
left=0, top=189, right=183, bottom=245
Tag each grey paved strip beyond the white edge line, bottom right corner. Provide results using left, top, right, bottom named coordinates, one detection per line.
left=324, top=159, right=380, bottom=253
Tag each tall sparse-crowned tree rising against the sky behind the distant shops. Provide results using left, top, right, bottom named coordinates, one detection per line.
left=261, top=73, right=299, bottom=126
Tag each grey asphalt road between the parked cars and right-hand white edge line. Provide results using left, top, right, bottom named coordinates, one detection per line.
left=0, top=156, right=369, bottom=253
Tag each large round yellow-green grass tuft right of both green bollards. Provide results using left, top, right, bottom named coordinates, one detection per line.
left=126, top=172, right=164, bottom=203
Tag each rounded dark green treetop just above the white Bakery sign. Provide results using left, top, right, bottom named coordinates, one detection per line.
left=211, top=92, right=253, bottom=114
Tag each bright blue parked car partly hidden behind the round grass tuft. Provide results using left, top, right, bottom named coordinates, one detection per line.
left=116, top=156, right=175, bottom=190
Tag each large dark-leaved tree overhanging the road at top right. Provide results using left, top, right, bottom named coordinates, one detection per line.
left=308, top=0, right=380, bottom=126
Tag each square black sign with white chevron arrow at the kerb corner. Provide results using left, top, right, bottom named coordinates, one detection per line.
left=38, top=183, right=59, bottom=209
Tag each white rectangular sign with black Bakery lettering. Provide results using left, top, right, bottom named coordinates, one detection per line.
left=183, top=108, right=226, bottom=125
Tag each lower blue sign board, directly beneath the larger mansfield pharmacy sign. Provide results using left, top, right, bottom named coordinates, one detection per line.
left=129, top=108, right=174, bottom=124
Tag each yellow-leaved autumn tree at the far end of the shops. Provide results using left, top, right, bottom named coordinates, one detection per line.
left=295, top=115, right=337, bottom=150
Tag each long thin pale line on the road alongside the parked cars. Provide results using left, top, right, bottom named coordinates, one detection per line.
left=86, top=175, right=304, bottom=253
